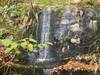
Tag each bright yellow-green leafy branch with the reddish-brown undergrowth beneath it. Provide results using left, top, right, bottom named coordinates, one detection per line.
left=0, top=38, right=52, bottom=74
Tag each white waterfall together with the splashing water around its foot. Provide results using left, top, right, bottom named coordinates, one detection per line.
left=35, top=7, right=58, bottom=68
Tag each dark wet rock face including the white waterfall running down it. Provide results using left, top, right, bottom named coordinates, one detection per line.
left=34, top=7, right=97, bottom=68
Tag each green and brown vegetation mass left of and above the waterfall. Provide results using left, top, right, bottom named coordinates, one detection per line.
left=0, top=0, right=100, bottom=75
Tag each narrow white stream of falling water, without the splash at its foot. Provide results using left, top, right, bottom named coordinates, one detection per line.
left=40, top=7, right=51, bottom=61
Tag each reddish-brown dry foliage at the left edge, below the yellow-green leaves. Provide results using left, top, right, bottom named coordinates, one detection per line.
left=0, top=43, right=16, bottom=68
